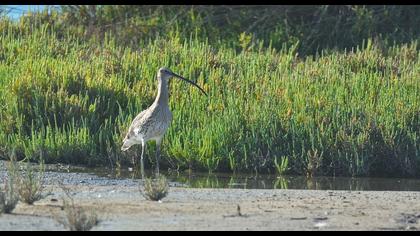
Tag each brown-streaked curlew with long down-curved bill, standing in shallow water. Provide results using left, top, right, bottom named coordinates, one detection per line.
left=121, top=67, right=207, bottom=177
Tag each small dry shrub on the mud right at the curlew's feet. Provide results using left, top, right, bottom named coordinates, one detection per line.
left=140, top=175, right=169, bottom=201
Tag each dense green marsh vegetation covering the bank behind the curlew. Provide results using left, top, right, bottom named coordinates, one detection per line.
left=0, top=7, right=420, bottom=176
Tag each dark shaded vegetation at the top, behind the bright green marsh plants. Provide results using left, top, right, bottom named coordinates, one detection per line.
left=45, top=5, right=420, bottom=55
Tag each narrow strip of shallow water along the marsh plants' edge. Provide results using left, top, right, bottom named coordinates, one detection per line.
left=60, top=165, right=420, bottom=191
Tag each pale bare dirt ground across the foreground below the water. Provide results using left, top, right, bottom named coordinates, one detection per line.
left=0, top=184, right=420, bottom=230
